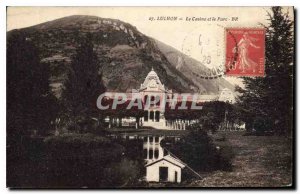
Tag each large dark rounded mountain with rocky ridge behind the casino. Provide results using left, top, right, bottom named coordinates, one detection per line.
left=7, top=15, right=233, bottom=96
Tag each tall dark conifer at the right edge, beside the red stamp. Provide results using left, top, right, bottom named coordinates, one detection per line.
left=237, top=7, right=294, bottom=133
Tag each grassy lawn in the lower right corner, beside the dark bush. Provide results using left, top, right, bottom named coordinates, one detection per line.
left=189, top=132, right=293, bottom=187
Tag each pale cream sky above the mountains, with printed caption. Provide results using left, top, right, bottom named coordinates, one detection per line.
left=7, top=7, right=293, bottom=86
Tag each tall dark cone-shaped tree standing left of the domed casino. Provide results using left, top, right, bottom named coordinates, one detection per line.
left=62, top=34, right=105, bottom=131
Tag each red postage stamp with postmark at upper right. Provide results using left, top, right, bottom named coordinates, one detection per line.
left=225, top=28, right=265, bottom=76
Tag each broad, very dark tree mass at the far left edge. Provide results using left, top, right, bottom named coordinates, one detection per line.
left=7, top=31, right=57, bottom=141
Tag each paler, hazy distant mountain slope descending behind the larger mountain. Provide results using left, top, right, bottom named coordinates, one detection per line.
left=153, top=39, right=235, bottom=94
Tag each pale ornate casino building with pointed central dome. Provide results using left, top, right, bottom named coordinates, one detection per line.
left=105, top=68, right=235, bottom=130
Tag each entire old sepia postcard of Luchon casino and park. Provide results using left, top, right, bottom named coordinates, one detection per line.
left=6, top=7, right=295, bottom=189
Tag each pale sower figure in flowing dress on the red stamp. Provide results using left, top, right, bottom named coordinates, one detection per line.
left=232, top=32, right=260, bottom=72
